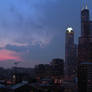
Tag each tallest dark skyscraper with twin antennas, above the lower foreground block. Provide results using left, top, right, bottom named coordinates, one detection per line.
left=78, top=6, right=92, bottom=63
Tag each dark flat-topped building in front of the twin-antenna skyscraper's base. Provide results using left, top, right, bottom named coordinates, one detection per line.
left=79, top=62, right=92, bottom=92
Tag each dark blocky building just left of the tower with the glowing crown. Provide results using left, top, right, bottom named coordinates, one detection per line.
left=50, top=58, right=64, bottom=84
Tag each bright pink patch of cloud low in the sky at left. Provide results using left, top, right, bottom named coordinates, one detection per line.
left=0, top=49, right=21, bottom=61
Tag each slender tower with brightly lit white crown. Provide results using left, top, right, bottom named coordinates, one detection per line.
left=65, top=27, right=77, bottom=76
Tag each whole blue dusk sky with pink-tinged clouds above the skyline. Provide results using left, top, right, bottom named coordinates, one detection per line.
left=0, top=0, right=92, bottom=67
